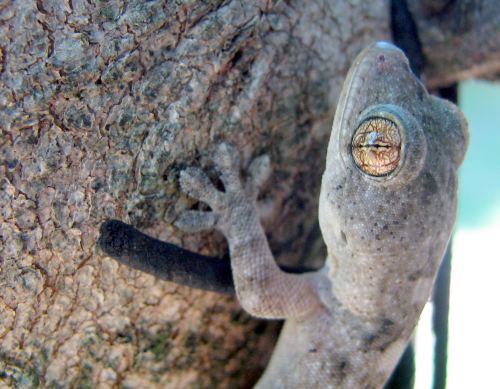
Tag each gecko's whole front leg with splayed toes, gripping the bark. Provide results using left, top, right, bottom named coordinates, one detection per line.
left=176, top=144, right=320, bottom=318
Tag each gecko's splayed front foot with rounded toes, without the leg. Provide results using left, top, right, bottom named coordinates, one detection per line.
left=175, top=143, right=270, bottom=236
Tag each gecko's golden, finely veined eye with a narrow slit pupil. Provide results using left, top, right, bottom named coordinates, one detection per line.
left=351, top=117, right=401, bottom=177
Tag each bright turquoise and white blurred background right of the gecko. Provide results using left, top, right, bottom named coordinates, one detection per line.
left=415, top=80, right=500, bottom=389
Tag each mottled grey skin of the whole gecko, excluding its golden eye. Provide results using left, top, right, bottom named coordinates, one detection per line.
left=177, top=43, right=468, bottom=388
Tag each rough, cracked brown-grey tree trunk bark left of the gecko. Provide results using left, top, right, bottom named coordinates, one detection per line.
left=0, top=0, right=499, bottom=388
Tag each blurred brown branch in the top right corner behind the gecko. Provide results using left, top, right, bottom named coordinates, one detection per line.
left=408, top=0, right=500, bottom=88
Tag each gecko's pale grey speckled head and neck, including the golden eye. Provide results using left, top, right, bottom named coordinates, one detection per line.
left=319, top=43, right=468, bottom=317
